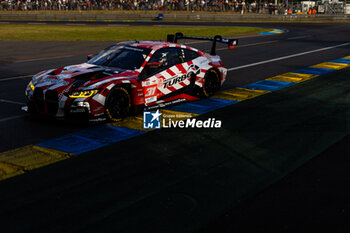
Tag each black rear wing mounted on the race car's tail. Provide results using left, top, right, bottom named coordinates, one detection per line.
left=167, top=32, right=238, bottom=55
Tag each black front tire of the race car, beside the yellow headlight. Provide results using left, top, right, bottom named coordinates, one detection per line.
left=105, top=87, right=131, bottom=121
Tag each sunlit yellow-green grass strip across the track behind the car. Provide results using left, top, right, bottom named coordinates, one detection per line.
left=0, top=24, right=267, bottom=41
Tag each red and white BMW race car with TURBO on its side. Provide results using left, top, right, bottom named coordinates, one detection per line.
left=25, top=33, right=237, bottom=121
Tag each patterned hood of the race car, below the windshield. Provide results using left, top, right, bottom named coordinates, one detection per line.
left=32, top=63, right=138, bottom=92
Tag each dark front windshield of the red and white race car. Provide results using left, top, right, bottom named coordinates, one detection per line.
left=88, top=45, right=151, bottom=70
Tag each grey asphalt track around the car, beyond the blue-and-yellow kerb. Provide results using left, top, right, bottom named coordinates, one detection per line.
left=0, top=23, right=350, bottom=151
